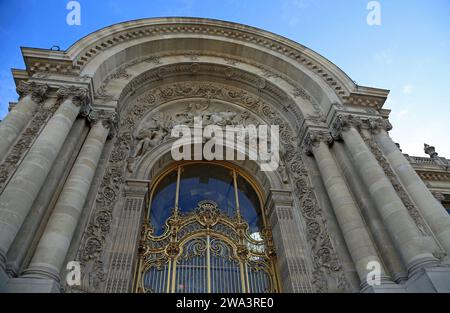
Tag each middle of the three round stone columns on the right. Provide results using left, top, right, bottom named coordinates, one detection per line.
left=333, top=115, right=437, bottom=274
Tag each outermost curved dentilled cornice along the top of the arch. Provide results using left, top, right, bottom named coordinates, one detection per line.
left=13, top=18, right=386, bottom=108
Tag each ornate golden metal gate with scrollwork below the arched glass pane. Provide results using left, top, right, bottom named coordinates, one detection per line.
left=135, top=200, right=279, bottom=293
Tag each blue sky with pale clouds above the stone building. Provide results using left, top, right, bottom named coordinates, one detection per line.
left=0, top=0, right=450, bottom=158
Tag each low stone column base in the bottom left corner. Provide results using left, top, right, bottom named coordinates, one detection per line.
left=5, top=277, right=60, bottom=293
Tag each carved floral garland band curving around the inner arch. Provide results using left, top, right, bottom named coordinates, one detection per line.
left=72, top=83, right=349, bottom=292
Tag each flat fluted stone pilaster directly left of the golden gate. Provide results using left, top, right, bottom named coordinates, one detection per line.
left=105, top=180, right=150, bottom=293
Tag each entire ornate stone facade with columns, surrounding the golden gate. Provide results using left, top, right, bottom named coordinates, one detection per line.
left=0, top=18, right=450, bottom=292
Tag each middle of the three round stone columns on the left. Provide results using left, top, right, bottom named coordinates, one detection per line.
left=0, top=87, right=87, bottom=268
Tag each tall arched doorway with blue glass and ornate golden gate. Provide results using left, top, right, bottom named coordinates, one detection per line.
left=135, top=162, right=279, bottom=293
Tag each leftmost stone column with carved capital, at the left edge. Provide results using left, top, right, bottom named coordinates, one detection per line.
left=0, top=82, right=48, bottom=162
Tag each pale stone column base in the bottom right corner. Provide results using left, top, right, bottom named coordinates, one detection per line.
left=405, top=266, right=450, bottom=293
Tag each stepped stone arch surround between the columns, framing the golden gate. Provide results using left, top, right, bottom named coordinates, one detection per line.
left=64, top=20, right=362, bottom=292
